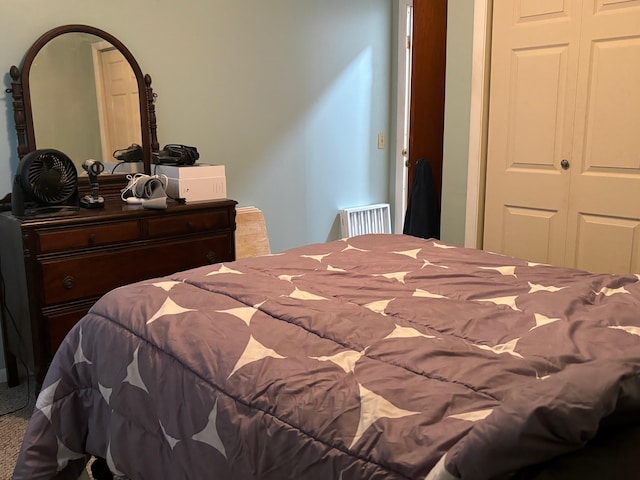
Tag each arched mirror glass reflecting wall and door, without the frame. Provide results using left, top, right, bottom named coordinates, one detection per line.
left=29, top=32, right=143, bottom=174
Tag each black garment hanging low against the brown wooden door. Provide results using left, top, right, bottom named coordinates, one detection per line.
left=402, top=158, right=440, bottom=239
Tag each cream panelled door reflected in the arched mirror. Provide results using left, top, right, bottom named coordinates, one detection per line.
left=93, top=42, right=142, bottom=169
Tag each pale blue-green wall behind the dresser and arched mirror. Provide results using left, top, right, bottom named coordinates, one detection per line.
left=0, top=0, right=394, bottom=368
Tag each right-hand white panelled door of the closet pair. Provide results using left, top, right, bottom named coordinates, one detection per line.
left=566, top=0, right=640, bottom=273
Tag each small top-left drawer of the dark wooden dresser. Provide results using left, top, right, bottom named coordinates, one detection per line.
left=35, top=220, right=140, bottom=253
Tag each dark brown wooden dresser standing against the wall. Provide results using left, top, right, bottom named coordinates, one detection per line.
left=0, top=197, right=236, bottom=386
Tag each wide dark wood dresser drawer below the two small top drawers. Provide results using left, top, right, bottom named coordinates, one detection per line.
left=40, top=232, right=234, bottom=305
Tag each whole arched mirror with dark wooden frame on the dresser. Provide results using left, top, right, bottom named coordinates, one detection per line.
left=10, top=25, right=159, bottom=190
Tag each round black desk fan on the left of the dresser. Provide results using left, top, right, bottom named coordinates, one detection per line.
left=12, top=148, right=78, bottom=216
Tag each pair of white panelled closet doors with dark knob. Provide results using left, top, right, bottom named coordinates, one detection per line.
left=484, top=0, right=640, bottom=272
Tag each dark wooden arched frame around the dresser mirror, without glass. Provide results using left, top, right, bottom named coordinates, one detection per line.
left=7, top=25, right=160, bottom=195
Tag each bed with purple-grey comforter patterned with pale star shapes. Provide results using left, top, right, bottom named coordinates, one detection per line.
left=13, top=235, right=640, bottom=480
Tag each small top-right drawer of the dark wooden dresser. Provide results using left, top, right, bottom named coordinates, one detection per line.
left=146, top=208, right=231, bottom=238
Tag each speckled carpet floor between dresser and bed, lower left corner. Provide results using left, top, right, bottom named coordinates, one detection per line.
left=0, top=379, right=91, bottom=480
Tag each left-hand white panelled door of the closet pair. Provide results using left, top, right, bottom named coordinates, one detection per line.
left=484, top=0, right=582, bottom=264
